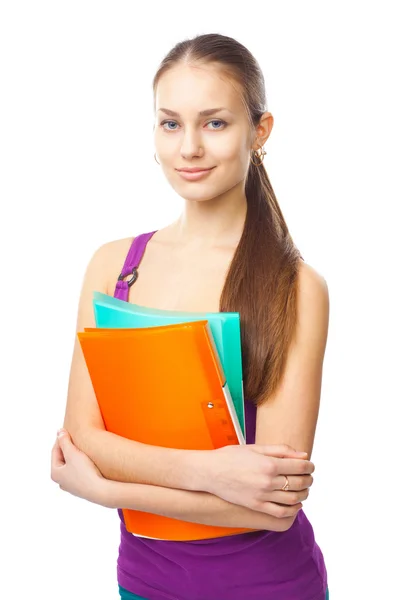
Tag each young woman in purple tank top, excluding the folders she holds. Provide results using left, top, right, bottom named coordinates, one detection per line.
left=52, top=34, right=329, bottom=600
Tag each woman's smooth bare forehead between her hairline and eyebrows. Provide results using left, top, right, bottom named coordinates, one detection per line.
left=155, top=65, right=244, bottom=116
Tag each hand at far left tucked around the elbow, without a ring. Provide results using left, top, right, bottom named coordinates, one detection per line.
left=51, top=429, right=108, bottom=506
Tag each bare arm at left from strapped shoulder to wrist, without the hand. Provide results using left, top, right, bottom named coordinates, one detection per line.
left=63, top=239, right=203, bottom=489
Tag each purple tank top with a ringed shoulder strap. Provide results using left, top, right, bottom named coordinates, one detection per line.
left=114, top=231, right=327, bottom=600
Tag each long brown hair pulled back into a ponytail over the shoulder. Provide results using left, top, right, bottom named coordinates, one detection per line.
left=153, top=33, right=303, bottom=405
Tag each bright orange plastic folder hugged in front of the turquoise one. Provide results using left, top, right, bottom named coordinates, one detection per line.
left=77, top=320, right=252, bottom=541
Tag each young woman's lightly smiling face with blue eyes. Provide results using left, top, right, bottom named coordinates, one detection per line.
left=154, top=65, right=253, bottom=201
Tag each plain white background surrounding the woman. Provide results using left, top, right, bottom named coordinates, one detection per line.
left=0, top=0, right=400, bottom=600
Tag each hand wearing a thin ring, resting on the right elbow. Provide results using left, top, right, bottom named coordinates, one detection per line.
left=198, top=444, right=315, bottom=518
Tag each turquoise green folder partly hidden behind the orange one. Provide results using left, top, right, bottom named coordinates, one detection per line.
left=93, top=292, right=246, bottom=439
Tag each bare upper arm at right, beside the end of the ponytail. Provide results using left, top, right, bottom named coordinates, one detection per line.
left=256, top=261, right=329, bottom=457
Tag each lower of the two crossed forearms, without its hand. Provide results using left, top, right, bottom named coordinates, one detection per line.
left=102, top=481, right=301, bottom=531
